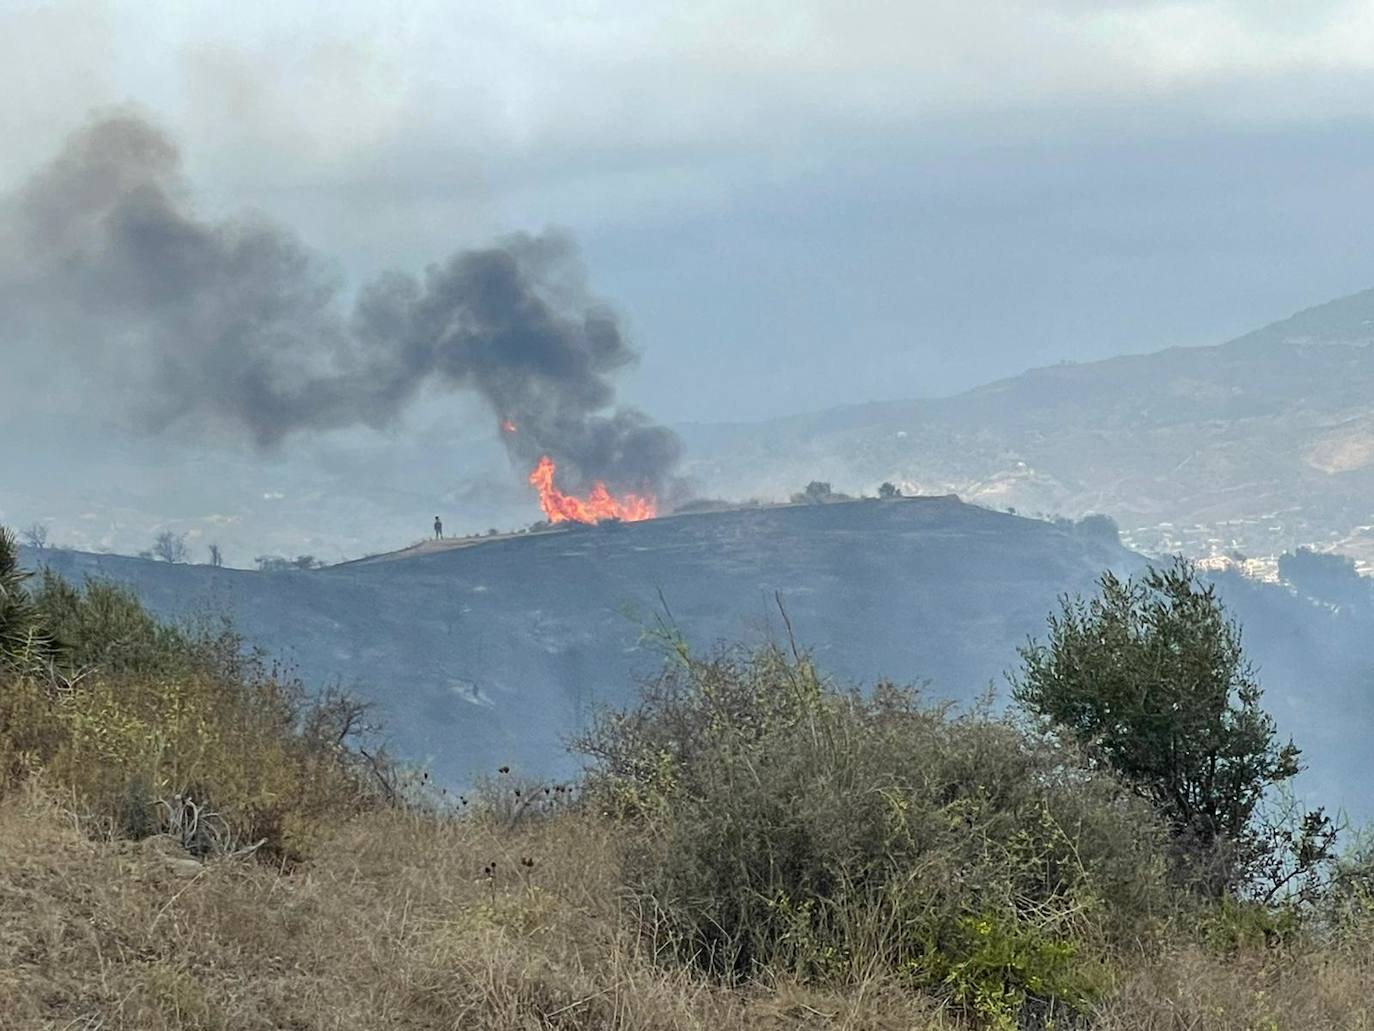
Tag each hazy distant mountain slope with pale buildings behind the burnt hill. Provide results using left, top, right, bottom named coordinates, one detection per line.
left=684, top=290, right=1374, bottom=568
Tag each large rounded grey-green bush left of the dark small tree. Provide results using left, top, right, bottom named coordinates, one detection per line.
left=577, top=647, right=1171, bottom=1027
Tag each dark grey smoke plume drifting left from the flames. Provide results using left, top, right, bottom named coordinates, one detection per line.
left=0, top=113, right=680, bottom=491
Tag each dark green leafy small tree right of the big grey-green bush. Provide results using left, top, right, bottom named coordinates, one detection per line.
left=1013, top=559, right=1329, bottom=898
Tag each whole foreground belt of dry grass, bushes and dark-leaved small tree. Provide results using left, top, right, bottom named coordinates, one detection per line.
left=0, top=527, right=1374, bottom=1030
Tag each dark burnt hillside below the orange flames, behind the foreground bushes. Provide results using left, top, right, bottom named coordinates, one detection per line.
left=25, top=498, right=1374, bottom=806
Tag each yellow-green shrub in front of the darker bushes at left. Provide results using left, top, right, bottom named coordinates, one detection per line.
left=0, top=662, right=371, bottom=862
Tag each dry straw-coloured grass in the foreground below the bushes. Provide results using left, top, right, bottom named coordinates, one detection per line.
left=0, top=789, right=954, bottom=1031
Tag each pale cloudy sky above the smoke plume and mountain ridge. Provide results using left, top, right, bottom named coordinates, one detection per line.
left=0, top=0, right=1374, bottom=421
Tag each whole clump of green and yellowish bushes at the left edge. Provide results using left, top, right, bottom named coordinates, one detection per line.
left=0, top=540, right=396, bottom=863
